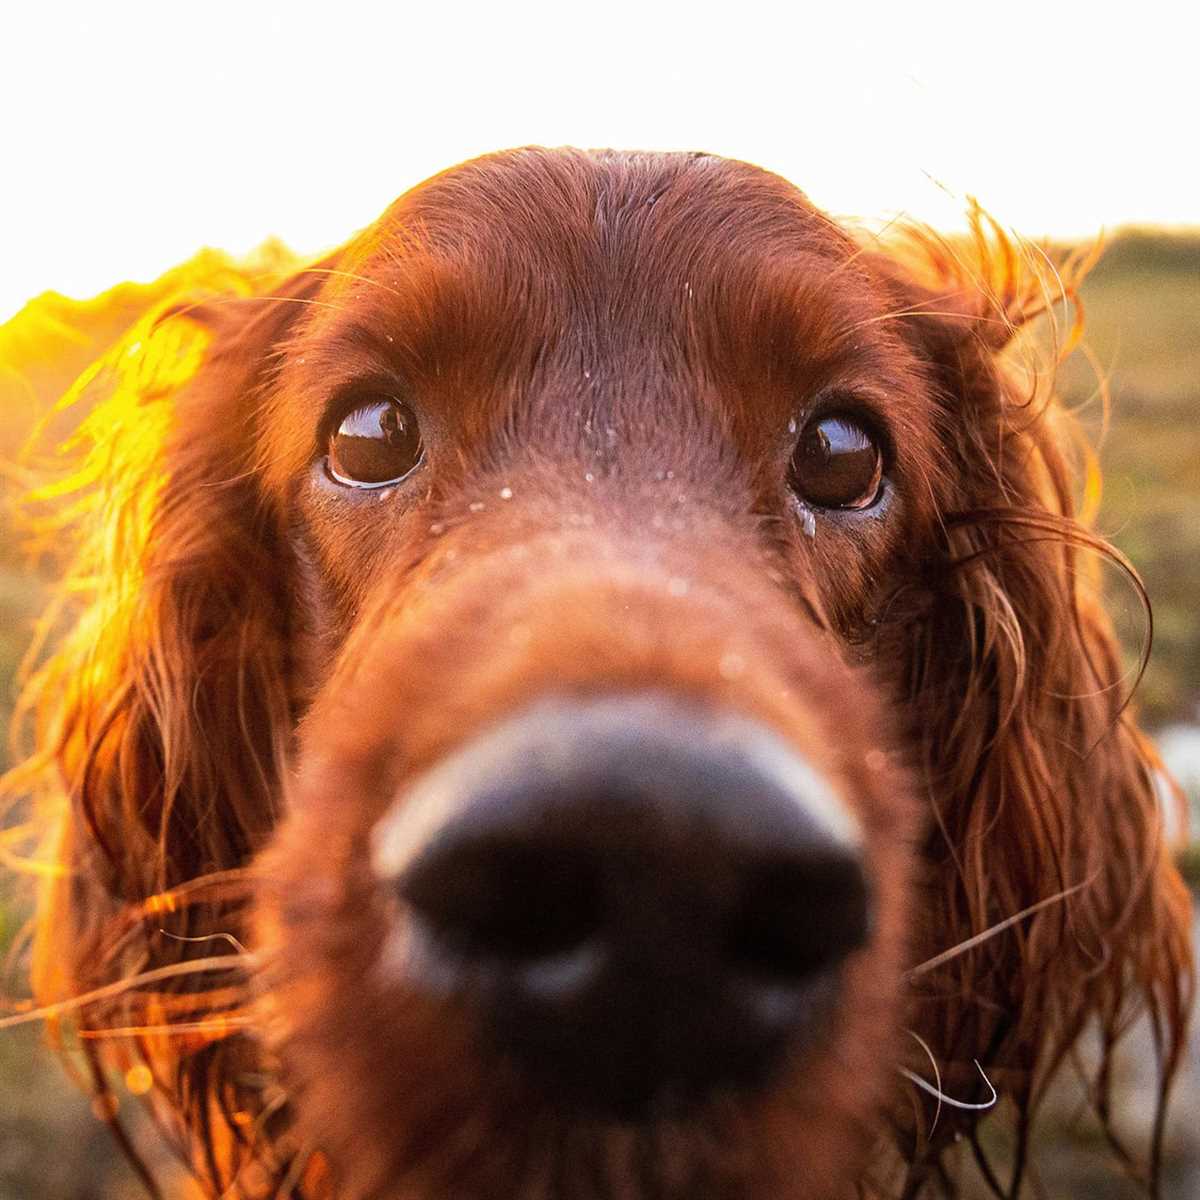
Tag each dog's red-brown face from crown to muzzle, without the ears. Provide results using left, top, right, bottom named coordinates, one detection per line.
left=262, top=155, right=921, bottom=1196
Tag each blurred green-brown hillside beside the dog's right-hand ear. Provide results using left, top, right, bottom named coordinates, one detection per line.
left=1060, top=230, right=1200, bottom=726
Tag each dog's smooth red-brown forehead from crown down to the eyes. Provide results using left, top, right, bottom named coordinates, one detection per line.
left=280, top=149, right=919, bottom=489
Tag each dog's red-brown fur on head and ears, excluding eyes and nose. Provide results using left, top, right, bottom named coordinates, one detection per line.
left=4, top=150, right=1190, bottom=1200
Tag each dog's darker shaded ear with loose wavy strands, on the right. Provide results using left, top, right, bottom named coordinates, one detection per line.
left=876, top=220, right=1192, bottom=1176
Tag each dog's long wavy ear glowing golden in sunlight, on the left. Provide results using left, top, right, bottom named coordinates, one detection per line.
left=10, top=258, right=333, bottom=1194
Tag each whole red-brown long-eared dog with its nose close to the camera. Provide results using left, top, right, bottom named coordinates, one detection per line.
left=4, top=149, right=1192, bottom=1200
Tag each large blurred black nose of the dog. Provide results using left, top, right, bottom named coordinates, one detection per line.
left=373, top=695, right=871, bottom=1117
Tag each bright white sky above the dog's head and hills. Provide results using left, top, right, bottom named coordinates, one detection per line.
left=0, top=0, right=1200, bottom=320
